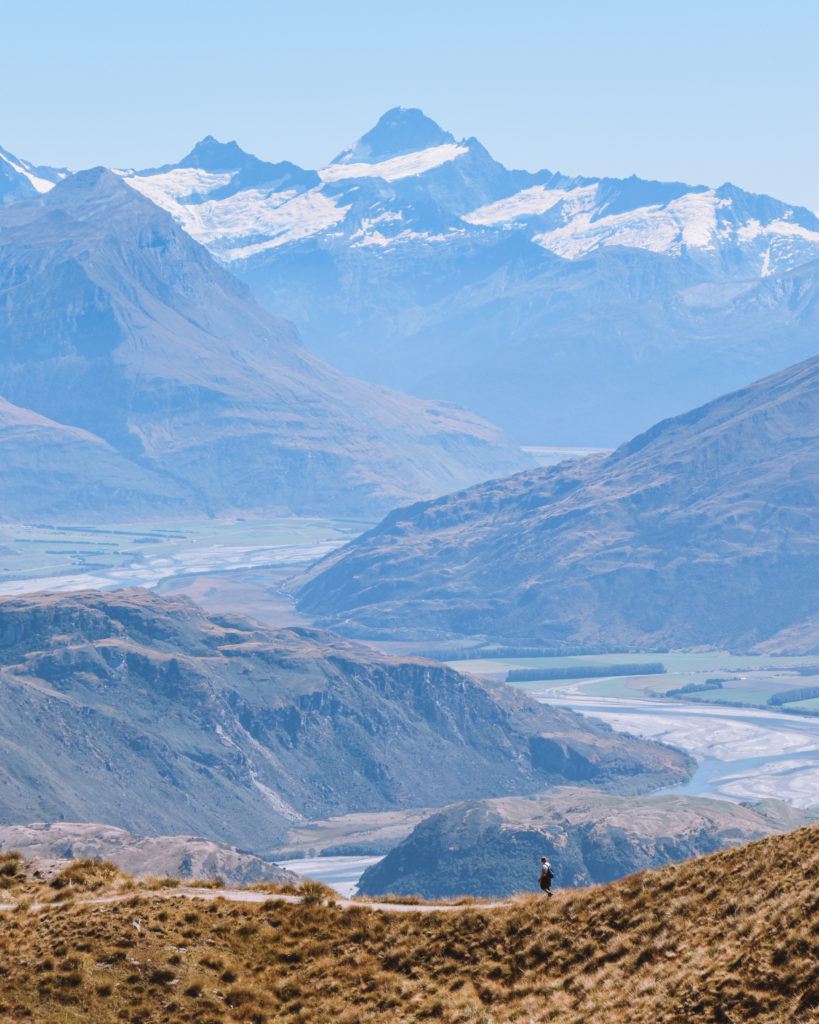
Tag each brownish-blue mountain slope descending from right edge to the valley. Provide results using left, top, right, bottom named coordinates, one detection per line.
left=300, top=357, right=819, bottom=653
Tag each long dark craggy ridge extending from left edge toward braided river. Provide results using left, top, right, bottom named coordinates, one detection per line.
left=0, top=589, right=692, bottom=850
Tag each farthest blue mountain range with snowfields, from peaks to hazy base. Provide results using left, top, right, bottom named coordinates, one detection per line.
left=113, top=109, right=819, bottom=445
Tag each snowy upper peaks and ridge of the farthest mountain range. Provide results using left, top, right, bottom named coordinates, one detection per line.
left=113, top=109, right=819, bottom=276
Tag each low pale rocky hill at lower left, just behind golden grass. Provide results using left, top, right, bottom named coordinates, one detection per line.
left=0, top=821, right=300, bottom=886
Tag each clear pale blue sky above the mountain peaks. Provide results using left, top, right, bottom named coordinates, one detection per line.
left=0, top=0, right=819, bottom=210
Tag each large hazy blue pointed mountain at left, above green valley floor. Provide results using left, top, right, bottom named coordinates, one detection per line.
left=0, top=169, right=521, bottom=518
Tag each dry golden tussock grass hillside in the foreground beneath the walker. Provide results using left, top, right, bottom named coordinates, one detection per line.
left=0, top=826, right=819, bottom=1024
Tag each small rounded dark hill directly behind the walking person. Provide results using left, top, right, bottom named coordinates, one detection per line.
left=359, top=790, right=819, bottom=899
